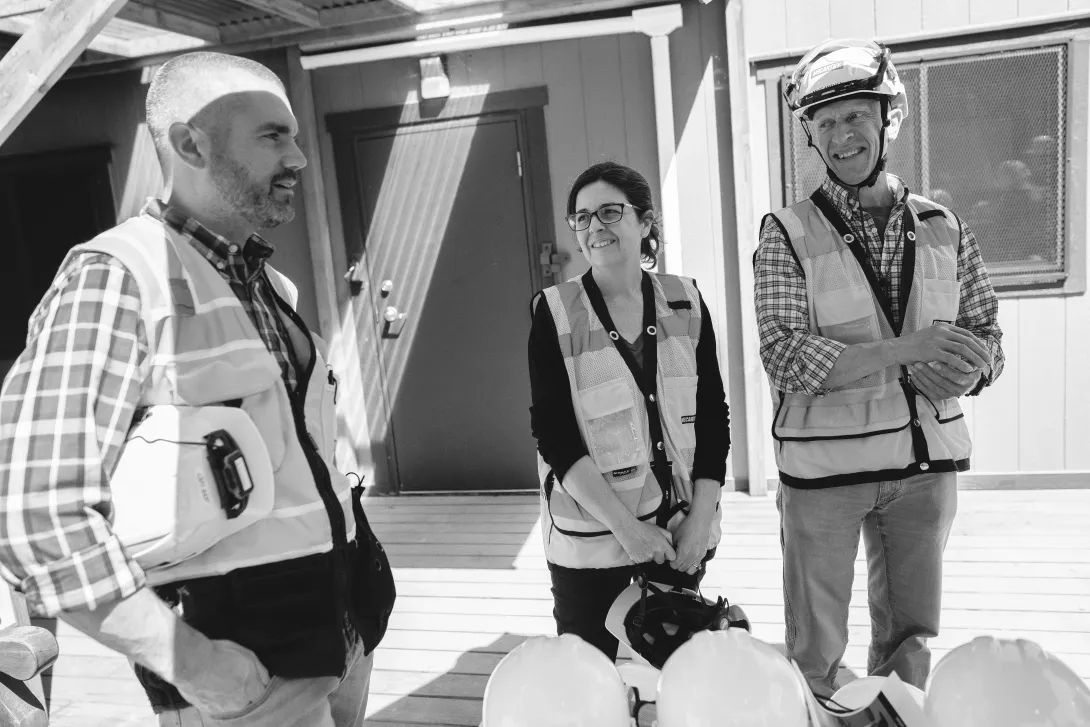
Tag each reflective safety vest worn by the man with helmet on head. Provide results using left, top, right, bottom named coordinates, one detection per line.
left=772, top=191, right=972, bottom=488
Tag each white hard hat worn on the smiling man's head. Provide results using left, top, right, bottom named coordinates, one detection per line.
left=784, top=39, right=908, bottom=119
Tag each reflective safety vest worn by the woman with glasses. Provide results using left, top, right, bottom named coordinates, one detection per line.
left=537, top=272, right=722, bottom=568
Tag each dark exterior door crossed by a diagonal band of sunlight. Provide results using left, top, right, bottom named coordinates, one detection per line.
left=349, top=116, right=537, bottom=492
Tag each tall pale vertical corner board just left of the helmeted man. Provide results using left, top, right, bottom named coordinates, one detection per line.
left=727, top=0, right=768, bottom=496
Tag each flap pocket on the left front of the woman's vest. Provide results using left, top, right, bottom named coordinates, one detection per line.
left=579, top=378, right=646, bottom=472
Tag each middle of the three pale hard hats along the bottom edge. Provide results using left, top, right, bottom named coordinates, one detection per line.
left=657, top=629, right=810, bottom=727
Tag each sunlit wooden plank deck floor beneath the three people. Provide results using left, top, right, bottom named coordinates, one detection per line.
left=38, top=490, right=1090, bottom=727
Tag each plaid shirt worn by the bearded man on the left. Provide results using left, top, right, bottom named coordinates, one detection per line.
left=0, top=199, right=295, bottom=616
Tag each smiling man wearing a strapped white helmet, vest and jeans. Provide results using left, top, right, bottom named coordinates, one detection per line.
left=753, top=40, right=1003, bottom=696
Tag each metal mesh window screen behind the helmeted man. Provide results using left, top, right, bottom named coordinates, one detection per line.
left=782, top=46, right=1067, bottom=278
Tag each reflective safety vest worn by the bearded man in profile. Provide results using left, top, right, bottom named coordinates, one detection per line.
left=71, top=215, right=355, bottom=585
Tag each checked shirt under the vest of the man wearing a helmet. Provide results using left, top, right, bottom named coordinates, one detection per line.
left=753, top=174, right=1004, bottom=395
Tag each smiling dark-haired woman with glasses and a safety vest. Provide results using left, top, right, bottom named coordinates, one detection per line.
left=529, top=162, right=730, bottom=659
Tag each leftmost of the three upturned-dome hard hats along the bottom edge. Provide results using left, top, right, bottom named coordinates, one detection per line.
left=481, top=633, right=632, bottom=727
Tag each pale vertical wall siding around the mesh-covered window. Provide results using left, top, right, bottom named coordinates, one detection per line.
left=744, top=0, right=1090, bottom=478
